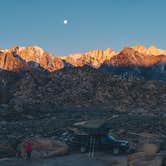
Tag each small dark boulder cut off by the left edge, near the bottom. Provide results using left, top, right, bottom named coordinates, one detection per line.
left=0, top=144, right=16, bottom=158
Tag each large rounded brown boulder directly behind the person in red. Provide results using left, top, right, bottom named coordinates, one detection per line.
left=18, top=138, right=69, bottom=159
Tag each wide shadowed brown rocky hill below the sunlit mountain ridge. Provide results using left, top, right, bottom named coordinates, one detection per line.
left=1, top=66, right=166, bottom=114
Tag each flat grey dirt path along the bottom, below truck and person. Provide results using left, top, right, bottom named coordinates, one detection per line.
left=0, top=154, right=127, bottom=166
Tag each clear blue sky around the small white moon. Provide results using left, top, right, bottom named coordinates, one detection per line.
left=0, top=0, right=166, bottom=55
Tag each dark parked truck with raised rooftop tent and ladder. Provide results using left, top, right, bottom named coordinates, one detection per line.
left=69, top=120, right=129, bottom=155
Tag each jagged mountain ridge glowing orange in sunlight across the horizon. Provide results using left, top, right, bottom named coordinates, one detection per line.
left=0, top=45, right=166, bottom=80
